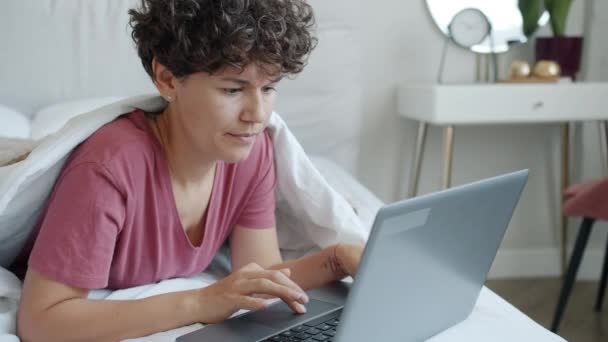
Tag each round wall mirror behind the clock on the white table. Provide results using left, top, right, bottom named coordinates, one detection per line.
left=426, top=0, right=549, bottom=53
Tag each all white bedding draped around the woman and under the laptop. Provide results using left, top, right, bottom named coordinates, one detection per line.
left=0, top=96, right=563, bottom=341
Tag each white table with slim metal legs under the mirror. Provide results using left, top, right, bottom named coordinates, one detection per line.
left=398, top=83, right=608, bottom=270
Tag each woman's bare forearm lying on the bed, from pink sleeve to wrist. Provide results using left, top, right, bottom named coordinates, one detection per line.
left=17, top=269, right=199, bottom=341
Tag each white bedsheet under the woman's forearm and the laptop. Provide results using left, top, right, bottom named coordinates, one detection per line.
left=0, top=267, right=564, bottom=342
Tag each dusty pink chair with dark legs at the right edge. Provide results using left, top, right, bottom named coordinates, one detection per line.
left=551, top=178, right=608, bottom=332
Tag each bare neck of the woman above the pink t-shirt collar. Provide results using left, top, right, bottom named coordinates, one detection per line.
left=150, top=106, right=217, bottom=188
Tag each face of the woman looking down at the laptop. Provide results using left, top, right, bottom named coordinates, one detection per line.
left=170, top=63, right=279, bottom=163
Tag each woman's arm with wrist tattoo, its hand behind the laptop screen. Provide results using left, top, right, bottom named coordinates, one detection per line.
left=230, top=225, right=363, bottom=289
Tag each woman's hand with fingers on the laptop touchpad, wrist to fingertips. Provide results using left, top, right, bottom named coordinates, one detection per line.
left=197, top=263, right=308, bottom=323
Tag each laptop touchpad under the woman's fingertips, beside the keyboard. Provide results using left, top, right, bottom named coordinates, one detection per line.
left=240, top=299, right=341, bottom=329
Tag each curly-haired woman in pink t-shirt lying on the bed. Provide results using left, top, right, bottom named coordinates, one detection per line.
left=17, top=0, right=362, bottom=341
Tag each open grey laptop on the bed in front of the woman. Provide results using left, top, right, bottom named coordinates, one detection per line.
left=177, top=170, right=528, bottom=342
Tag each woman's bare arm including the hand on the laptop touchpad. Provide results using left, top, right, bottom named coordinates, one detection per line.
left=17, top=264, right=308, bottom=342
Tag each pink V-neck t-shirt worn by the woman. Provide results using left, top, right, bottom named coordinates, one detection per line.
left=29, top=110, right=276, bottom=289
